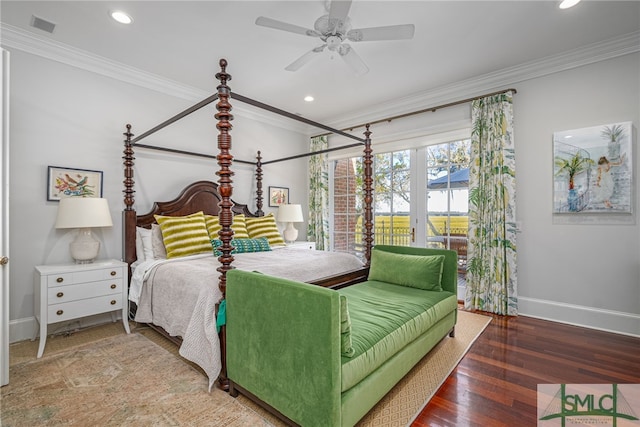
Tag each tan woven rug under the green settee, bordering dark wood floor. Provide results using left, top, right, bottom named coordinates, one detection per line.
left=238, top=310, right=491, bottom=427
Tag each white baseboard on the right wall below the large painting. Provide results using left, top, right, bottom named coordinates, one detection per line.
left=518, top=297, right=640, bottom=337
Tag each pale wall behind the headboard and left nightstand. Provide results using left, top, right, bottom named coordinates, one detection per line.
left=10, top=50, right=308, bottom=342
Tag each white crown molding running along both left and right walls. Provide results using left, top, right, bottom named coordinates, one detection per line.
left=0, top=24, right=640, bottom=134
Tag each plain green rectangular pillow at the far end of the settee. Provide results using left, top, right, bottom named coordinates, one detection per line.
left=369, top=248, right=444, bottom=291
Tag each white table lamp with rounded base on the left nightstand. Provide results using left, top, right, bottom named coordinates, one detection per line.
left=56, top=197, right=113, bottom=264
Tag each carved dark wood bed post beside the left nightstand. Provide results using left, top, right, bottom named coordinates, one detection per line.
left=122, top=124, right=137, bottom=270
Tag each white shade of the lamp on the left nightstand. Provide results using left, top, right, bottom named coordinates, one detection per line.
left=56, top=197, right=113, bottom=228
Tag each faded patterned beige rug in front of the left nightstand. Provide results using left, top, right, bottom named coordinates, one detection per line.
left=0, top=331, right=270, bottom=427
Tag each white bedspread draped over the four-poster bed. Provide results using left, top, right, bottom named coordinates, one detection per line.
left=129, top=247, right=362, bottom=390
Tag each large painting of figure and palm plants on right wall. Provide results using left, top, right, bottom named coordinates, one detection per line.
left=553, top=122, right=633, bottom=214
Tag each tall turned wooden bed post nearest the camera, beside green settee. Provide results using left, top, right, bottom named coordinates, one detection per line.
left=215, top=59, right=233, bottom=299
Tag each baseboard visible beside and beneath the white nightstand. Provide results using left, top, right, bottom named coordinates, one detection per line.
left=9, top=312, right=127, bottom=343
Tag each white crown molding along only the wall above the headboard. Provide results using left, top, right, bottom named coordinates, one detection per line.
left=0, top=24, right=309, bottom=134
